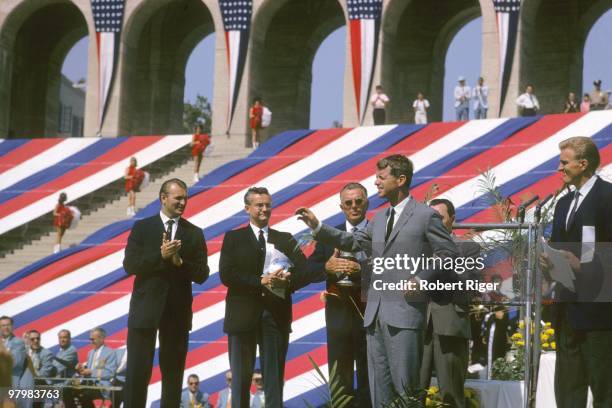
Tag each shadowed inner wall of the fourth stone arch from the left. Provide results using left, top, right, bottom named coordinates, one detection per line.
left=380, top=0, right=482, bottom=123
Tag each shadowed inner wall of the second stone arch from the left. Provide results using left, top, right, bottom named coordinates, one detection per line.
left=115, top=0, right=217, bottom=135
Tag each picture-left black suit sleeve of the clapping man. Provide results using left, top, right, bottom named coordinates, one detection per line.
left=123, top=222, right=167, bottom=276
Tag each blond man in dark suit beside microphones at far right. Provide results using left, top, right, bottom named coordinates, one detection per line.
left=541, top=137, right=612, bottom=408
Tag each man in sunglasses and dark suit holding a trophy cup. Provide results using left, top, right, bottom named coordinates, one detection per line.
left=308, top=183, right=371, bottom=408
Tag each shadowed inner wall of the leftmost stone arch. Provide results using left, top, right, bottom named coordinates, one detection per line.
left=0, top=0, right=91, bottom=137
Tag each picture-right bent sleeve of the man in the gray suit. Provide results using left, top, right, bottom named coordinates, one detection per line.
left=417, top=211, right=459, bottom=281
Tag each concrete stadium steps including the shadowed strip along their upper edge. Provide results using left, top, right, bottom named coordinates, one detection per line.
left=0, top=137, right=252, bottom=279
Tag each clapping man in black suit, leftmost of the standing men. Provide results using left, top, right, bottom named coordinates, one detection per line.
left=123, top=179, right=209, bottom=408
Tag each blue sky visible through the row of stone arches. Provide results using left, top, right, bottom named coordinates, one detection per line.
left=62, top=10, right=612, bottom=128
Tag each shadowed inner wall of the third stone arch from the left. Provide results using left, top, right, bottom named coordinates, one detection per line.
left=246, top=0, right=346, bottom=139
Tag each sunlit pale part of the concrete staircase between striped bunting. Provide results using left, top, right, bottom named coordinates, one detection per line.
left=0, top=136, right=252, bottom=279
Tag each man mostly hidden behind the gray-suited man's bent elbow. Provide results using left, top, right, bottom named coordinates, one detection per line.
left=421, top=198, right=480, bottom=408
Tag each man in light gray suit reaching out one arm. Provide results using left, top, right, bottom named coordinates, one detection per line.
left=296, top=154, right=458, bottom=407
